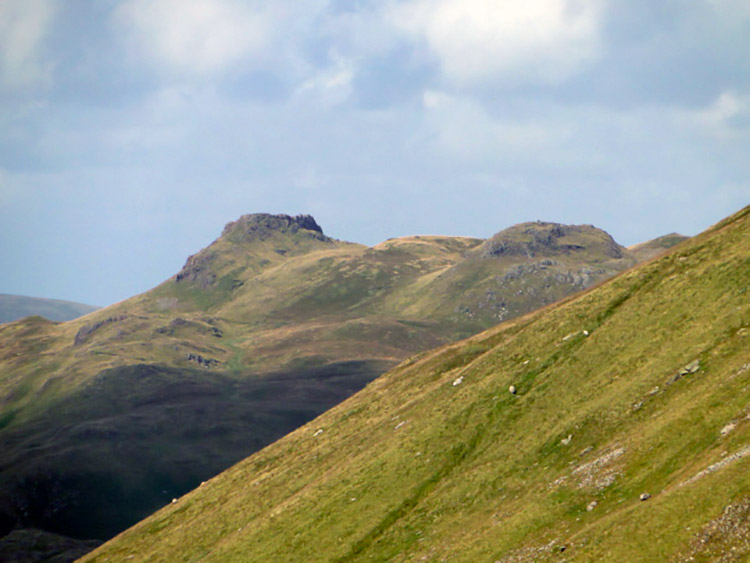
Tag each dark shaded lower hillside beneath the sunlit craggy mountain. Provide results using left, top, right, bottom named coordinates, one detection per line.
left=0, top=362, right=388, bottom=538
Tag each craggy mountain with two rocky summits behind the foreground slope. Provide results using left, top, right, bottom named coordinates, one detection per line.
left=0, top=214, right=668, bottom=539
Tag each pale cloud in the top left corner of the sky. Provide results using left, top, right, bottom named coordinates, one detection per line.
left=0, top=0, right=55, bottom=90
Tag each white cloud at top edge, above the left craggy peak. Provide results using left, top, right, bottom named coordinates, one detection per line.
left=116, top=0, right=280, bottom=75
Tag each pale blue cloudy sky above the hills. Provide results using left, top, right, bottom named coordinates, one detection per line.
left=0, top=0, right=750, bottom=306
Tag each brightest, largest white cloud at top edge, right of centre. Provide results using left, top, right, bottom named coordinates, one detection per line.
left=390, top=0, right=601, bottom=85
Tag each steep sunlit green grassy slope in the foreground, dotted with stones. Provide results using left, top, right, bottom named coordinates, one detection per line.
left=84, top=208, right=750, bottom=562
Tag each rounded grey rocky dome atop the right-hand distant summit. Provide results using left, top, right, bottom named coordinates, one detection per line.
left=480, top=221, right=624, bottom=259
